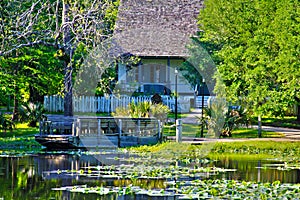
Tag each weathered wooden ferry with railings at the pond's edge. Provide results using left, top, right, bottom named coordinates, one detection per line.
left=35, top=115, right=162, bottom=149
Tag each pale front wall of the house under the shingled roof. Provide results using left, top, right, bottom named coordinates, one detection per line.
left=118, top=58, right=194, bottom=96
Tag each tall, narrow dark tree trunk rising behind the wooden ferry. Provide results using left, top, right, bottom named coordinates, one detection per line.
left=62, top=0, right=73, bottom=116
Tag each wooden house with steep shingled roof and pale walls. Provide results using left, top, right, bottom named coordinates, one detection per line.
left=114, top=0, right=203, bottom=96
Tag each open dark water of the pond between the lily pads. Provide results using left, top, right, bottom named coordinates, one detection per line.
left=0, top=153, right=300, bottom=200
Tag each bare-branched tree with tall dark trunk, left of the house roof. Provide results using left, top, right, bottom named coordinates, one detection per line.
left=0, top=0, right=118, bottom=116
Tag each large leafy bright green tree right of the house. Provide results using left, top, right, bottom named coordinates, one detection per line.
left=199, top=0, right=300, bottom=133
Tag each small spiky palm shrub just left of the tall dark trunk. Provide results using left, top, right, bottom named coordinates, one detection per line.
left=19, top=102, right=45, bottom=127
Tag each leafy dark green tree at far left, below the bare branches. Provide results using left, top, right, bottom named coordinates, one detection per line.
left=0, top=47, right=63, bottom=120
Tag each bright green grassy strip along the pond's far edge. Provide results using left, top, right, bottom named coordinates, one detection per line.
left=127, top=141, right=300, bottom=162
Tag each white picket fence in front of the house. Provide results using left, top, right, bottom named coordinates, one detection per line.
left=44, top=95, right=190, bottom=113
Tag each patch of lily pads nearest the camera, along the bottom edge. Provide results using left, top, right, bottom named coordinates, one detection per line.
left=53, top=179, right=300, bottom=199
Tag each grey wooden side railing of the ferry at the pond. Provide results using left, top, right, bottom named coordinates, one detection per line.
left=39, top=115, right=162, bottom=147
